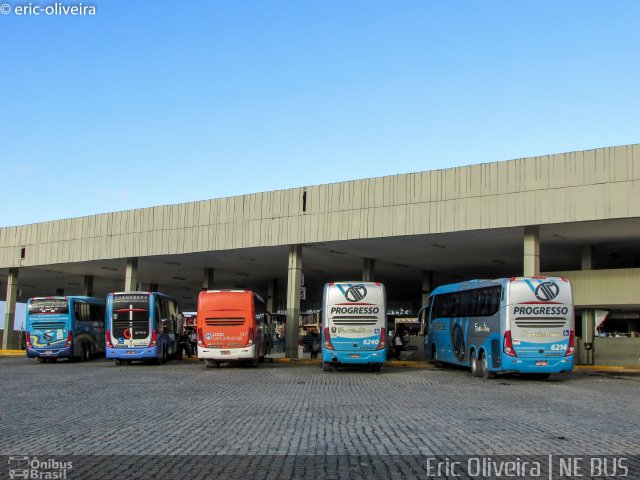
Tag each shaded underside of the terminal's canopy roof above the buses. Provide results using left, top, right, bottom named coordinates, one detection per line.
left=0, top=218, right=640, bottom=311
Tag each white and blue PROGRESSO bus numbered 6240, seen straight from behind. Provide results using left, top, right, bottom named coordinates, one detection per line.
left=322, top=282, right=387, bottom=372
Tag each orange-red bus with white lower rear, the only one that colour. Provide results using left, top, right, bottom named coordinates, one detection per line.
left=196, top=290, right=269, bottom=367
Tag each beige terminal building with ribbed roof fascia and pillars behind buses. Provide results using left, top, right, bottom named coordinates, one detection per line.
left=0, top=144, right=640, bottom=366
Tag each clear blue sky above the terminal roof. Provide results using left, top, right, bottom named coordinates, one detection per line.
left=0, top=0, right=640, bottom=226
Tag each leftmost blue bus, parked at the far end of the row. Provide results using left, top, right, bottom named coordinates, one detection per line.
left=25, top=296, right=105, bottom=362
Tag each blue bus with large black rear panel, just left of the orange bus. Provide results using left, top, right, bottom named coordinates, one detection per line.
left=106, top=292, right=182, bottom=365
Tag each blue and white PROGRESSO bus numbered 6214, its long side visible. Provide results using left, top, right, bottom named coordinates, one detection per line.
left=425, top=277, right=575, bottom=378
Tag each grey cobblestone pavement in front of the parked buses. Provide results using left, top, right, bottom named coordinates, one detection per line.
left=0, top=358, right=640, bottom=478
